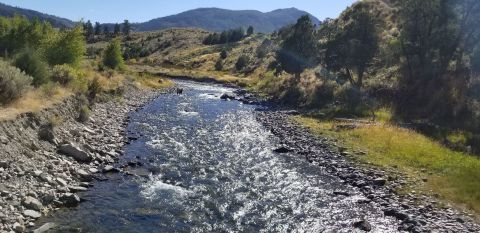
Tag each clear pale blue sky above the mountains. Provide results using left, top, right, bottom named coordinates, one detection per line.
left=0, top=0, right=356, bottom=23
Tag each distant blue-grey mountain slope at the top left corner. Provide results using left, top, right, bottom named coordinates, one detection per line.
left=0, top=3, right=75, bottom=28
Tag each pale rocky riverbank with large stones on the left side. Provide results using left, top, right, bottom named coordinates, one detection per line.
left=0, top=87, right=171, bottom=232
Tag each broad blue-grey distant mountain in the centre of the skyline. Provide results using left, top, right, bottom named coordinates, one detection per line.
left=134, top=8, right=320, bottom=33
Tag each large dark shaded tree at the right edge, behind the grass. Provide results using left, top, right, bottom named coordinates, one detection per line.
left=395, top=0, right=480, bottom=120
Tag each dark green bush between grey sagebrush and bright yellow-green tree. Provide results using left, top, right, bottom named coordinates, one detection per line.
left=13, top=48, right=48, bottom=87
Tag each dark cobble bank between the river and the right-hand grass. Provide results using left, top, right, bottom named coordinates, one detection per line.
left=258, top=111, right=480, bottom=232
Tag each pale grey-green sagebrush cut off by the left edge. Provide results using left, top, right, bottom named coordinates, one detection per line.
left=0, top=61, right=32, bottom=104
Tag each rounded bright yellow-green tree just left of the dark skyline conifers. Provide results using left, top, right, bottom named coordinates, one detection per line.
left=45, top=26, right=86, bottom=66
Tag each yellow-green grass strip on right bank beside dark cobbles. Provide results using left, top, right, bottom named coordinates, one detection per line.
left=292, top=116, right=480, bottom=216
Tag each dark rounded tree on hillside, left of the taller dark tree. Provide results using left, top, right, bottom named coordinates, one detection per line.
left=277, top=15, right=317, bottom=74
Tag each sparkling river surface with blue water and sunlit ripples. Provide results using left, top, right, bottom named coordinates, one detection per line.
left=42, top=82, right=397, bottom=233
